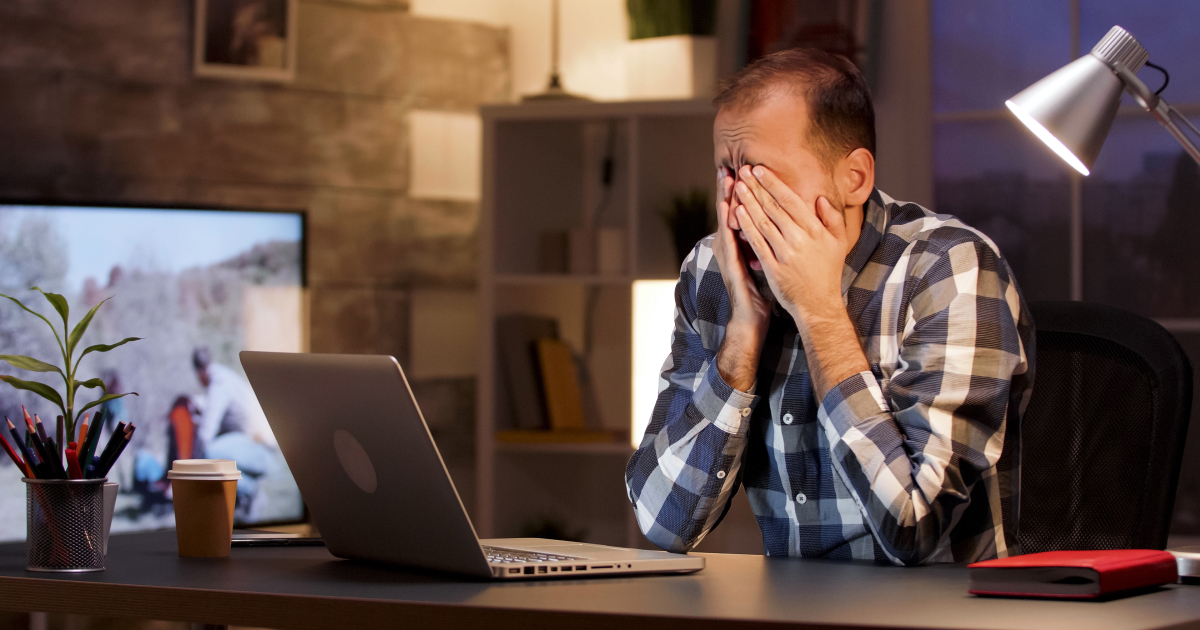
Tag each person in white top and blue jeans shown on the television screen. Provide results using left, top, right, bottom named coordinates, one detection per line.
left=192, top=347, right=278, bottom=521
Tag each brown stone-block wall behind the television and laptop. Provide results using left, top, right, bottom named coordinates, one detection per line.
left=0, top=0, right=501, bottom=505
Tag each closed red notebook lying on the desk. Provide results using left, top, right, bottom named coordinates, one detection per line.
left=967, top=550, right=1178, bottom=599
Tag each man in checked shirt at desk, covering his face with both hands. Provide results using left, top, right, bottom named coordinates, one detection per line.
left=625, top=49, right=1033, bottom=565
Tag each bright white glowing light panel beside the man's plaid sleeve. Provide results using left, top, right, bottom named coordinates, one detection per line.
left=629, top=280, right=676, bottom=449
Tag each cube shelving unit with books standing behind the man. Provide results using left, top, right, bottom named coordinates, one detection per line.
left=475, top=101, right=715, bottom=546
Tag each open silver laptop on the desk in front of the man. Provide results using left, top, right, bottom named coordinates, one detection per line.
left=241, top=352, right=704, bottom=580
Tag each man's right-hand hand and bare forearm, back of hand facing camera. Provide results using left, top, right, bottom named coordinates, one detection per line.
left=734, top=166, right=870, bottom=402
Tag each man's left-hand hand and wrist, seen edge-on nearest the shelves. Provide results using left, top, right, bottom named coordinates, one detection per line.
left=713, top=169, right=770, bottom=391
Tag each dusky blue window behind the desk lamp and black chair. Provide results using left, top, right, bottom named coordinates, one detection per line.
left=931, top=0, right=1200, bottom=534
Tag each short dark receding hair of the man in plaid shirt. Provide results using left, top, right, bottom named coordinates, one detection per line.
left=713, top=48, right=875, bottom=164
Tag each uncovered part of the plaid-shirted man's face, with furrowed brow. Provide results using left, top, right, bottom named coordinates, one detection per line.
left=713, top=90, right=842, bottom=290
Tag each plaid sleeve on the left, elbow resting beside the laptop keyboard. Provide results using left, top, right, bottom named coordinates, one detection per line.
left=625, top=241, right=758, bottom=552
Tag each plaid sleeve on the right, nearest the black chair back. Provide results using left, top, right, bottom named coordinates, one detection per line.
left=817, top=241, right=1028, bottom=565
